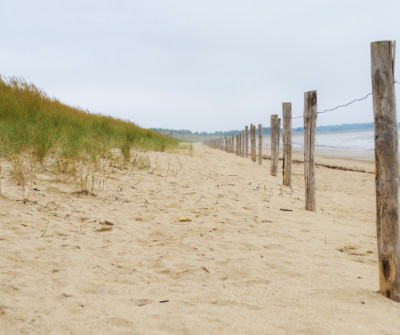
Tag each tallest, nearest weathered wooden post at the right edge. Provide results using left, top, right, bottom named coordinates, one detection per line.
left=371, top=41, right=400, bottom=302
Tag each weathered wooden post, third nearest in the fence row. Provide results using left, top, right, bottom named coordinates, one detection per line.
left=282, top=102, right=292, bottom=187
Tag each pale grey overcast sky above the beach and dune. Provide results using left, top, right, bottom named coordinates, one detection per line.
left=0, top=0, right=400, bottom=131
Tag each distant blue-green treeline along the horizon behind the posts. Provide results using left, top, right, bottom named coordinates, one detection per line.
left=152, top=122, right=376, bottom=137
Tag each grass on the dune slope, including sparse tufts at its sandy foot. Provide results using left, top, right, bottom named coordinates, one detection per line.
left=0, top=76, right=178, bottom=202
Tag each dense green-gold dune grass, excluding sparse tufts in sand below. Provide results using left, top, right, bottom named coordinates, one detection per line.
left=0, top=76, right=178, bottom=163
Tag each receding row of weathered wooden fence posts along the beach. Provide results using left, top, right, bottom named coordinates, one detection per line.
left=205, top=41, right=400, bottom=302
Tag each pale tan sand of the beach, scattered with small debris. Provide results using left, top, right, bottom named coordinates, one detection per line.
left=0, top=144, right=400, bottom=334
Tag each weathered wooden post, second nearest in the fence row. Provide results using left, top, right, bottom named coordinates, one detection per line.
left=304, top=91, right=317, bottom=211
